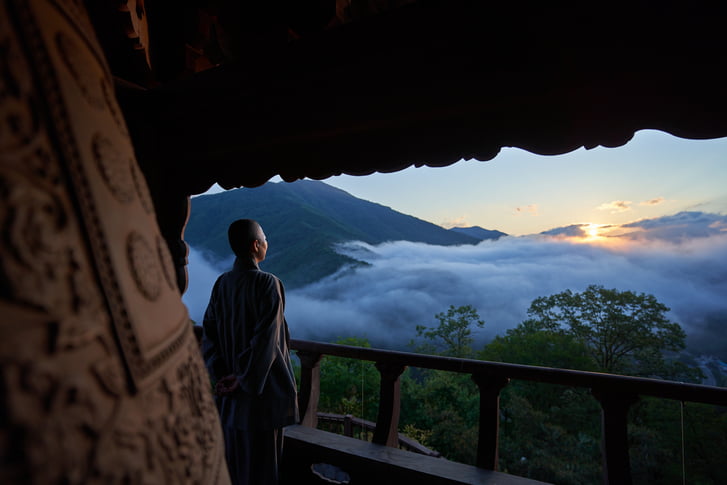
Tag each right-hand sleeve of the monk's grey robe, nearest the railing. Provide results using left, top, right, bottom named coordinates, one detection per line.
left=238, top=277, right=283, bottom=395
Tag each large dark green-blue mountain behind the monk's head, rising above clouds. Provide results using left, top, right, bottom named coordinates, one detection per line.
left=184, top=180, right=480, bottom=288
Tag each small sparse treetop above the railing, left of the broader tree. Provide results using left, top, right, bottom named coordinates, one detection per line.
left=415, top=305, right=485, bottom=358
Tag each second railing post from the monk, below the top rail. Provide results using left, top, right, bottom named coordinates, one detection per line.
left=372, top=362, right=406, bottom=448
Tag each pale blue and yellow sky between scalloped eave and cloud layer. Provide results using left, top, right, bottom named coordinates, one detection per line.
left=324, top=130, right=727, bottom=235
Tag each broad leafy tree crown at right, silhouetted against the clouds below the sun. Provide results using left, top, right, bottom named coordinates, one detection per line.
left=527, top=285, right=701, bottom=381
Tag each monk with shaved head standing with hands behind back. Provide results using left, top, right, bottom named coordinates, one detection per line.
left=202, top=219, right=298, bottom=485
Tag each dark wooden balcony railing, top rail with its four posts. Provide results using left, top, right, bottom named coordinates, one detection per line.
left=291, top=340, right=727, bottom=484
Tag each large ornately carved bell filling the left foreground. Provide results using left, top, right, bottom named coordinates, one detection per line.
left=0, top=0, right=229, bottom=484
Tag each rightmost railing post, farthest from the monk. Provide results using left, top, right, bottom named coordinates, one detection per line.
left=591, top=389, right=639, bottom=485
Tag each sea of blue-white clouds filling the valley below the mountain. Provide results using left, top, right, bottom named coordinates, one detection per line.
left=183, top=212, right=727, bottom=350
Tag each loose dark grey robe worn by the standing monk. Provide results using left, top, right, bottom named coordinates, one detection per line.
left=202, top=258, right=298, bottom=483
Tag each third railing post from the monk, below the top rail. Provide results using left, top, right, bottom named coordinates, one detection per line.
left=472, top=374, right=510, bottom=470
